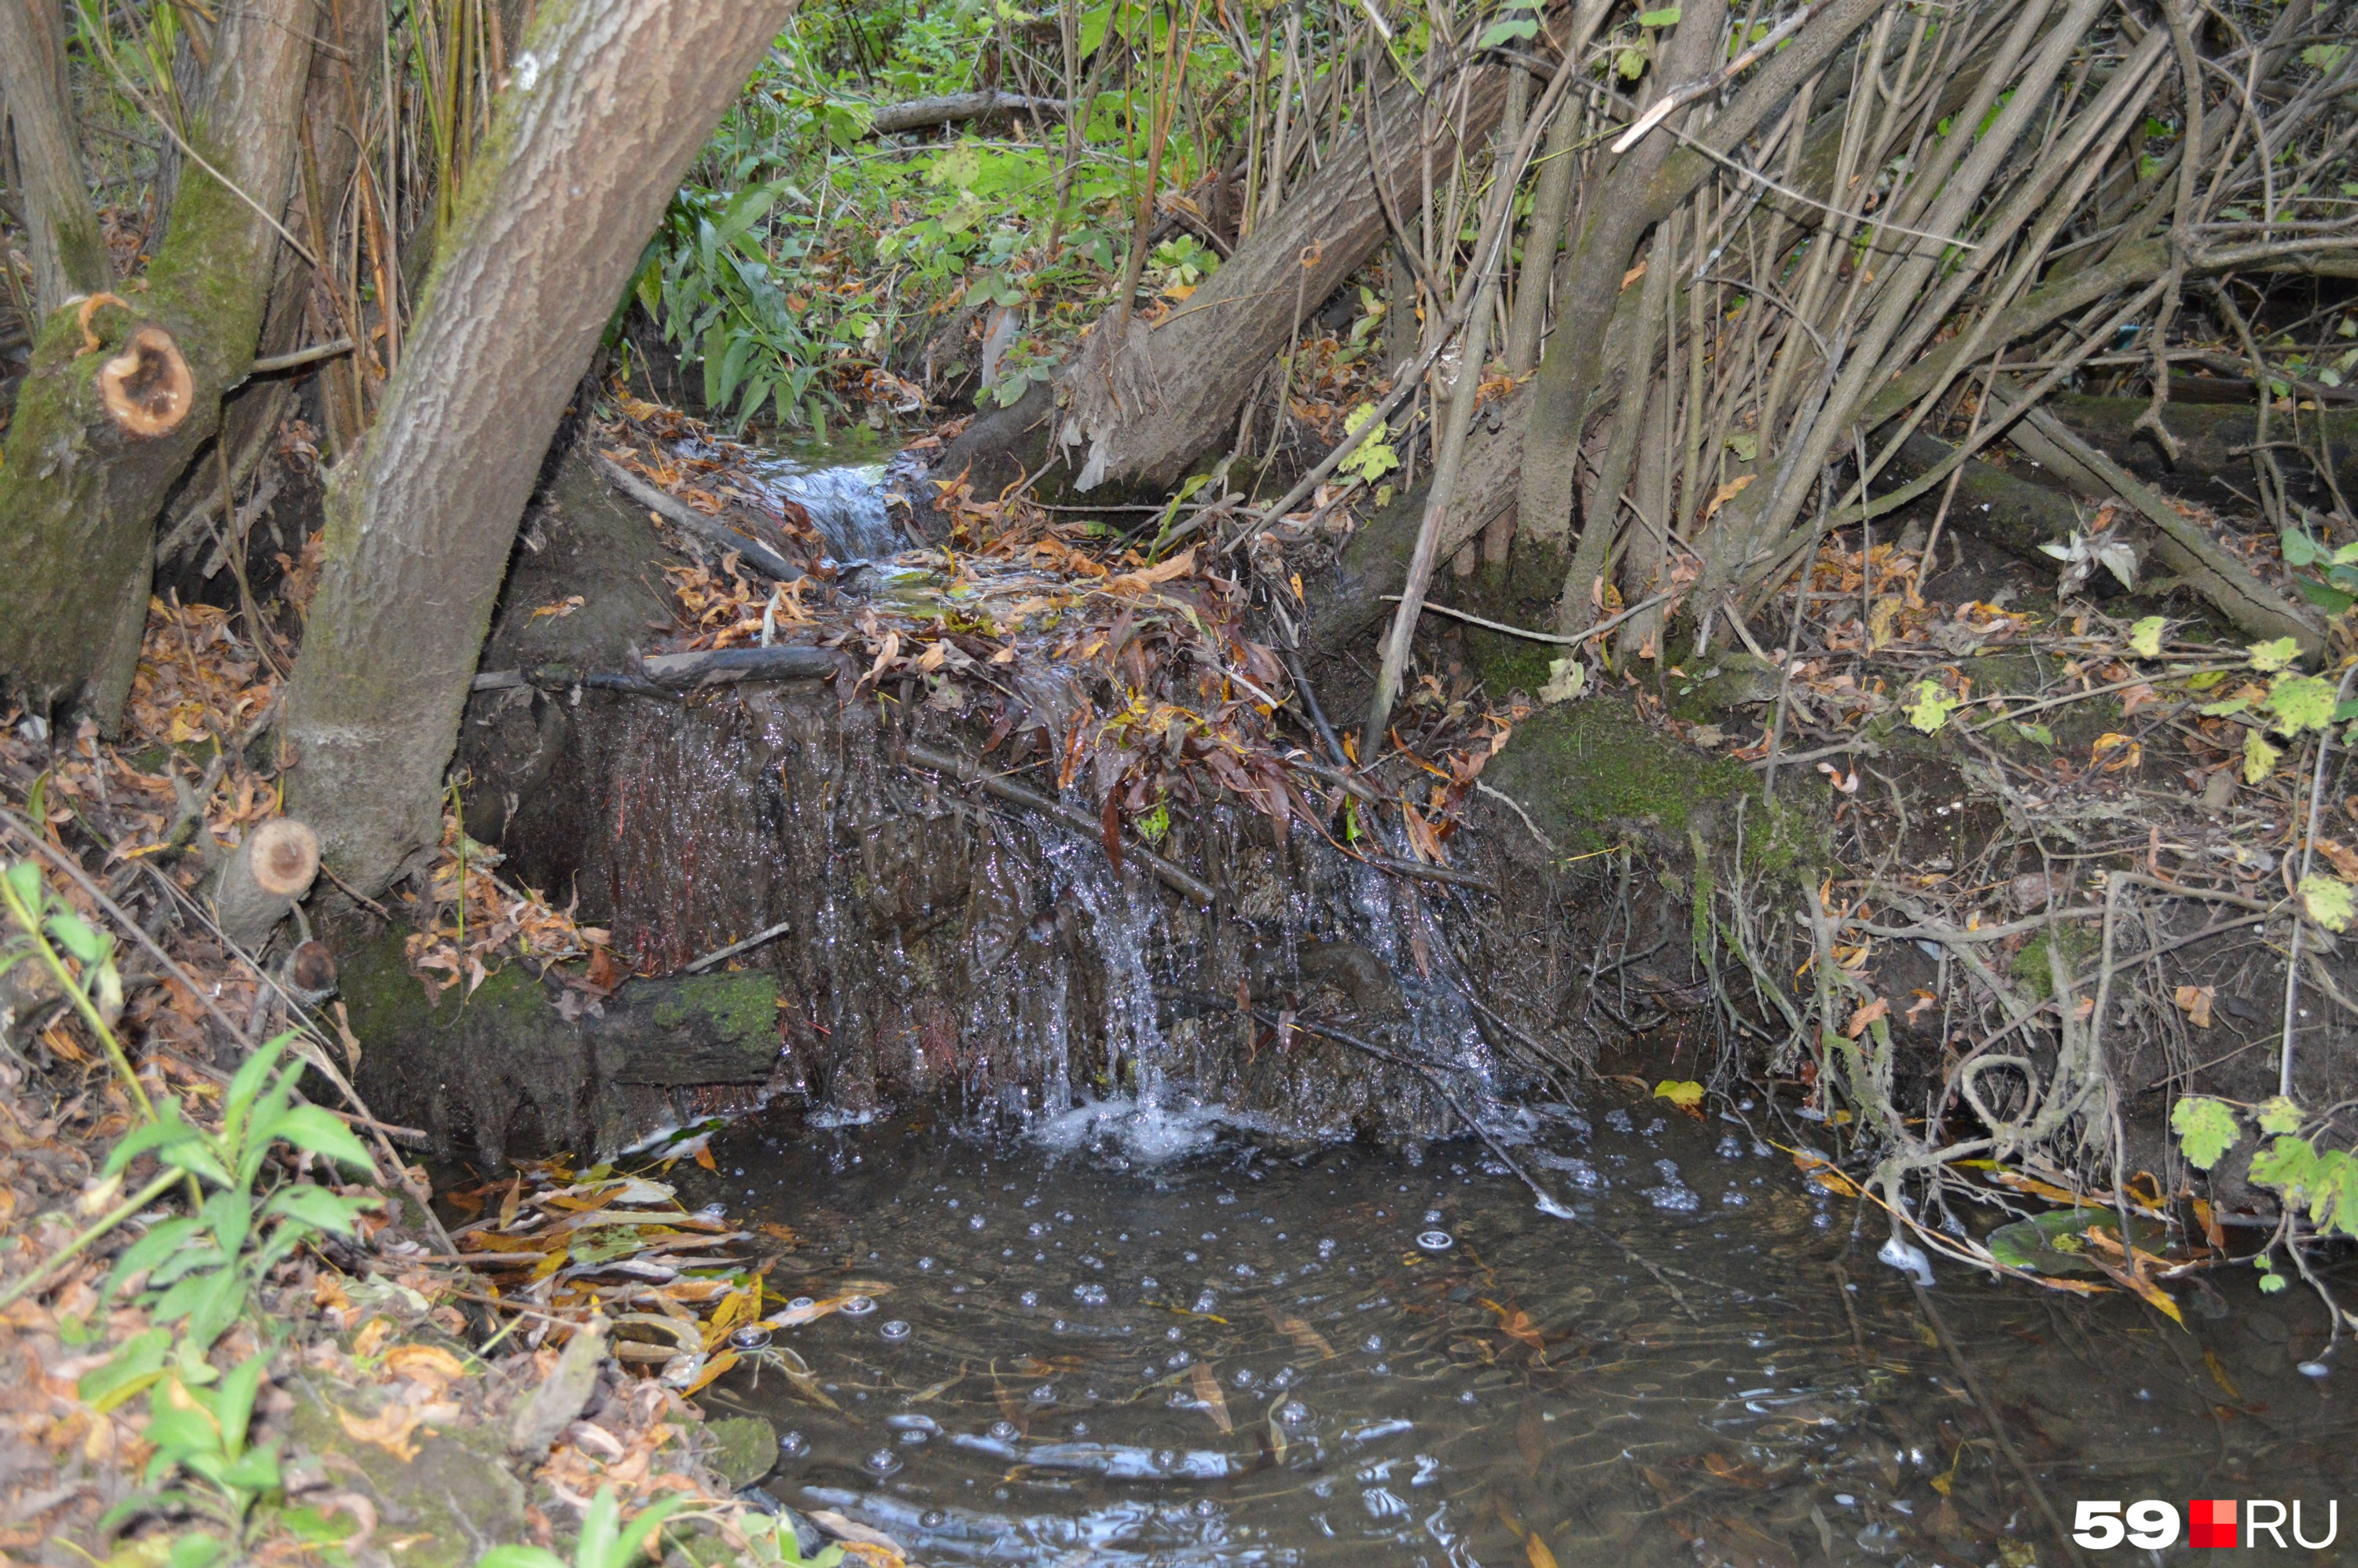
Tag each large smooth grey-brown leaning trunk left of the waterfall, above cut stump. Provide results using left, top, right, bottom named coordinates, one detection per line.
left=285, top=0, right=790, bottom=894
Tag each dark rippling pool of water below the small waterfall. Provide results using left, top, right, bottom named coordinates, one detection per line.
left=705, top=1106, right=2358, bottom=1568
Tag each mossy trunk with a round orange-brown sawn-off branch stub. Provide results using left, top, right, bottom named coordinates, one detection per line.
left=0, top=0, right=311, bottom=726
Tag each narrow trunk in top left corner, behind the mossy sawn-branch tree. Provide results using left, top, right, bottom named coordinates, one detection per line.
left=0, top=0, right=116, bottom=321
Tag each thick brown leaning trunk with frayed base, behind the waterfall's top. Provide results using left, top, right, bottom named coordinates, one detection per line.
left=934, top=24, right=1537, bottom=493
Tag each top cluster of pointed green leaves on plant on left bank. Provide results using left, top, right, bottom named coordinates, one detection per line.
left=106, top=1035, right=377, bottom=1351
